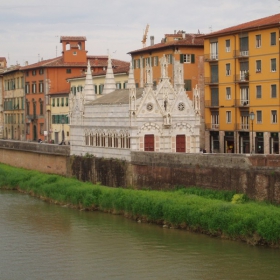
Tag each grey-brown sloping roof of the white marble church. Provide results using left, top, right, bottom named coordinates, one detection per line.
left=89, top=88, right=143, bottom=105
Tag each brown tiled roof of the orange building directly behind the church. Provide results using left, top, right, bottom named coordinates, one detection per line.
left=128, top=34, right=204, bottom=54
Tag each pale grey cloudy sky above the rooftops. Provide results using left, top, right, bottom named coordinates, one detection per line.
left=0, top=0, right=280, bottom=65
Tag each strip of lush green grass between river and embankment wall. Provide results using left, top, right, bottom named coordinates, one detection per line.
left=0, top=164, right=280, bottom=247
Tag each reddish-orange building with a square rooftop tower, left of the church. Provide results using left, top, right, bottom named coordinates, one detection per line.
left=21, top=36, right=129, bottom=141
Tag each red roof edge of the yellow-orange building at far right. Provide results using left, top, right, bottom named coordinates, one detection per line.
left=202, top=14, right=280, bottom=38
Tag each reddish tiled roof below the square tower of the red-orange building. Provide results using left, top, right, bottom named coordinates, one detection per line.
left=21, top=56, right=129, bottom=70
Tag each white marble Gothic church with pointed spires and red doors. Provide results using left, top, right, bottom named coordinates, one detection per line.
left=69, top=56, right=200, bottom=160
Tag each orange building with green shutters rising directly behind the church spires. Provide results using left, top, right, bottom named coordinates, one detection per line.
left=129, top=30, right=204, bottom=148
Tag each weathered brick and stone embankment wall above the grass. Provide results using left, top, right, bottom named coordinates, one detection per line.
left=0, top=141, right=280, bottom=203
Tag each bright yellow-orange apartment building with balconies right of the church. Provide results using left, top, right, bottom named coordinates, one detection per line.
left=204, top=14, right=280, bottom=154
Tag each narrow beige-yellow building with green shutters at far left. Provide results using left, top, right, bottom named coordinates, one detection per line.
left=2, top=65, right=26, bottom=140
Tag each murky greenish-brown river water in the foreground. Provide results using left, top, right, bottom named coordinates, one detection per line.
left=0, top=190, right=280, bottom=280
